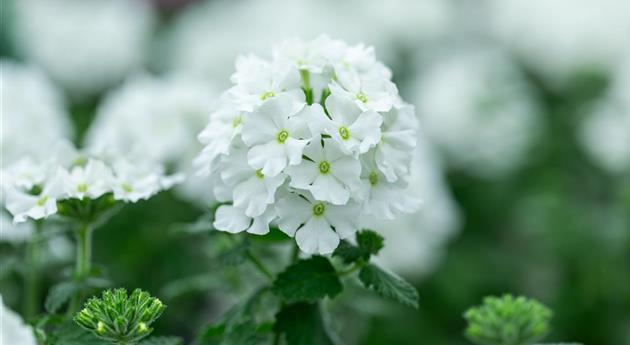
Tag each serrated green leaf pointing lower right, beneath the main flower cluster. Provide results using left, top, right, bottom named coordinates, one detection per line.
left=359, top=264, right=419, bottom=308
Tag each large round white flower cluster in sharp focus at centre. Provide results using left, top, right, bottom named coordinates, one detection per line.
left=196, top=36, right=419, bottom=254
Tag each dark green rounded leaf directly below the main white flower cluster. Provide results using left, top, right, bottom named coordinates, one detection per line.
left=271, top=256, right=343, bottom=303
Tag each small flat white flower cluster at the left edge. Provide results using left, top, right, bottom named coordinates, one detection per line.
left=1, top=142, right=180, bottom=223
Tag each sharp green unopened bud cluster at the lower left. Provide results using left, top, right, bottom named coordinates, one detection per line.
left=74, top=289, right=166, bottom=344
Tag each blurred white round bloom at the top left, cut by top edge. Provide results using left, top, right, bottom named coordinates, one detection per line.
left=15, top=0, right=154, bottom=96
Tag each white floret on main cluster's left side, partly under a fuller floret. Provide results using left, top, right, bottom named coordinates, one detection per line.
left=220, top=140, right=286, bottom=217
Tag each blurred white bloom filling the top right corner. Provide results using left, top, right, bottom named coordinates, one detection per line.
left=487, top=0, right=630, bottom=86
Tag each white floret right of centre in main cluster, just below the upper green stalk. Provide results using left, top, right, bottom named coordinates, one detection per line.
left=310, top=94, right=383, bottom=157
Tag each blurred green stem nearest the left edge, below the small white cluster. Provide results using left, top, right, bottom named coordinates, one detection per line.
left=24, top=220, right=43, bottom=319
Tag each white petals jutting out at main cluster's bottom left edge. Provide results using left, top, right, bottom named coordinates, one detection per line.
left=213, top=205, right=276, bottom=235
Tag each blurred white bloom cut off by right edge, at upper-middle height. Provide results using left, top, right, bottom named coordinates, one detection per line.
left=579, top=59, right=630, bottom=174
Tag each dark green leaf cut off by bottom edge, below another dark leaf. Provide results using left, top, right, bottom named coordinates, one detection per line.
left=273, top=303, right=336, bottom=345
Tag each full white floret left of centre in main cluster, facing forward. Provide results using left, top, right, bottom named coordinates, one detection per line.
left=242, top=94, right=310, bottom=177
